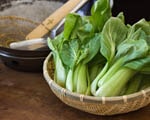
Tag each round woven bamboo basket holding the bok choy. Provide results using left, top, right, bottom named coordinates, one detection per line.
left=43, top=53, right=150, bottom=115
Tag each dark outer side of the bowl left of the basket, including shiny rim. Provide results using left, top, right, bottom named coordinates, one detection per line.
left=0, top=47, right=50, bottom=72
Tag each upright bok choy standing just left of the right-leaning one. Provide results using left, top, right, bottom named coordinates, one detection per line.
left=60, top=14, right=101, bottom=94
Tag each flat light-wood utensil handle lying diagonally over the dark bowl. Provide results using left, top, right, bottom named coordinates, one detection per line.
left=26, top=0, right=88, bottom=39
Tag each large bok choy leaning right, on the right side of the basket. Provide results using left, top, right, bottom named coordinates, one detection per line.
left=91, top=18, right=150, bottom=96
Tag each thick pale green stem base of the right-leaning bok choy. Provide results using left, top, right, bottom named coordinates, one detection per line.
left=96, top=67, right=136, bottom=97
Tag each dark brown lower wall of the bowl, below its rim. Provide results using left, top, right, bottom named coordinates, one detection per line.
left=1, top=54, right=45, bottom=72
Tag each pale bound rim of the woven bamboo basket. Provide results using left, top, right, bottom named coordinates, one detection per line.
left=43, top=52, right=150, bottom=104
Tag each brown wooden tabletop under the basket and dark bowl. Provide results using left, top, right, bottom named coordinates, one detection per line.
left=0, top=61, right=150, bottom=120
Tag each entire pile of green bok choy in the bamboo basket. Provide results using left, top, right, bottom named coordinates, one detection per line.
left=48, top=0, right=150, bottom=96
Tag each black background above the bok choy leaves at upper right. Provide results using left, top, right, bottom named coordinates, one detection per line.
left=112, top=0, right=150, bottom=24
